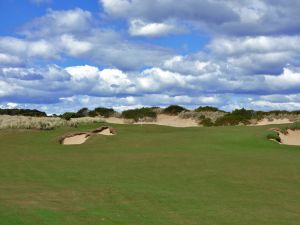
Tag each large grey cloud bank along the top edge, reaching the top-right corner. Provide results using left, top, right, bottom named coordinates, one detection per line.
left=100, top=0, right=300, bottom=36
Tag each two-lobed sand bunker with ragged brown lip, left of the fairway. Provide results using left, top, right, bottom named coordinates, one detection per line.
left=59, top=127, right=116, bottom=145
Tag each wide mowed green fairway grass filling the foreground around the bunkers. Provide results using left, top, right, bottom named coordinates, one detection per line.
left=0, top=124, right=300, bottom=225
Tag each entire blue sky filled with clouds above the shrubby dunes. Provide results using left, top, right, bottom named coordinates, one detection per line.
left=0, top=0, right=300, bottom=114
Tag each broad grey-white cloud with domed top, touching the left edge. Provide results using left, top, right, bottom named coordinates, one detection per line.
left=0, top=8, right=173, bottom=70
